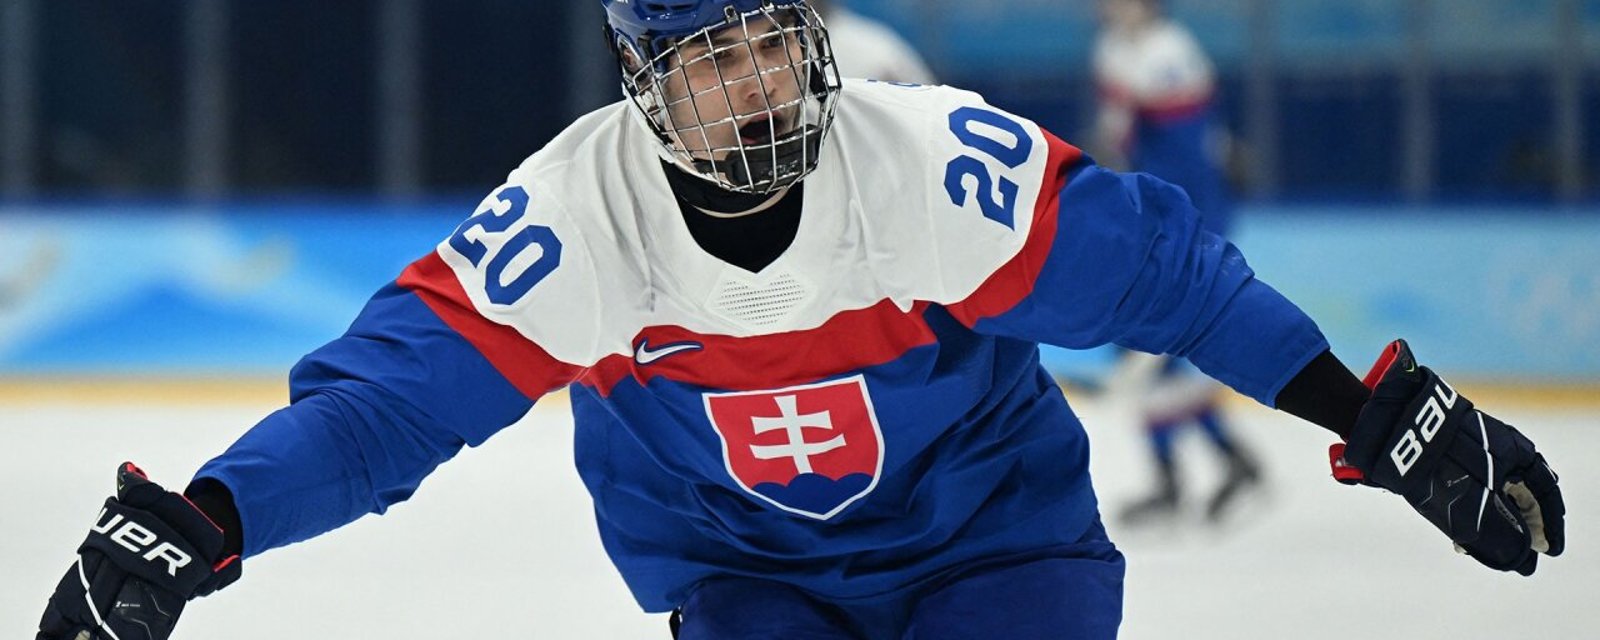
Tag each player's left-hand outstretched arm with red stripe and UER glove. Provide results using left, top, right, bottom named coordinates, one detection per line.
left=38, top=181, right=578, bottom=640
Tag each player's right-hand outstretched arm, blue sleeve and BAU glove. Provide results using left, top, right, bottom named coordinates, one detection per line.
left=974, top=136, right=1565, bottom=573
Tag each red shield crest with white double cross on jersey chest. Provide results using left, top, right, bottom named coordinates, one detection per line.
left=704, top=376, right=883, bottom=520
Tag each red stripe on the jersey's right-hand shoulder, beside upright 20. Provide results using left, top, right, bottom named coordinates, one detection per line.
left=949, top=130, right=1083, bottom=326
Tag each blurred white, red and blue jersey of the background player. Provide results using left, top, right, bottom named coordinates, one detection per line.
left=1093, top=19, right=1232, bottom=234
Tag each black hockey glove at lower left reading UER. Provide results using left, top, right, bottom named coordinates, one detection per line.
left=37, top=462, right=240, bottom=640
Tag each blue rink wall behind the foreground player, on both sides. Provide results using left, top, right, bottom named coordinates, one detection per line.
left=0, top=203, right=1600, bottom=382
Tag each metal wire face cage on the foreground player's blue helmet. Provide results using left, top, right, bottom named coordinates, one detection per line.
left=616, top=2, right=840, bottom=194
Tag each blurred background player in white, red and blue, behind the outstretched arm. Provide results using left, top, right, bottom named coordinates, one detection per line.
left=1091, top=0, right=1261, bottom=523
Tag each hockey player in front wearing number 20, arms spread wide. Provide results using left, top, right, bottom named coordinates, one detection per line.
left=38, top=0, right=1563, bottom=640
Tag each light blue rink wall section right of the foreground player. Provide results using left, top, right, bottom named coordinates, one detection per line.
left=1045, top=206, right=1600, bottom=382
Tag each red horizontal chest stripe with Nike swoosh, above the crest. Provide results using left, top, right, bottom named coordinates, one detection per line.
left=579, top=301, right=936, bottom=395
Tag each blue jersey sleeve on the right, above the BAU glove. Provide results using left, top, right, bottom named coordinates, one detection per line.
left=973, top=157, right=1328, bottom=406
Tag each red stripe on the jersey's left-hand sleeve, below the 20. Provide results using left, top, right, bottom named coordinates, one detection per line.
left=395, top=253, right=582, bottom=400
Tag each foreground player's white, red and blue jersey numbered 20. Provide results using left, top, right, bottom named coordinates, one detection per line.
left=200, top=80, right=1326, bottom=611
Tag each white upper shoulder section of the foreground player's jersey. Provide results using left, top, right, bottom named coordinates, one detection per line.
left=440, top=80, right=1056, bottom=377
